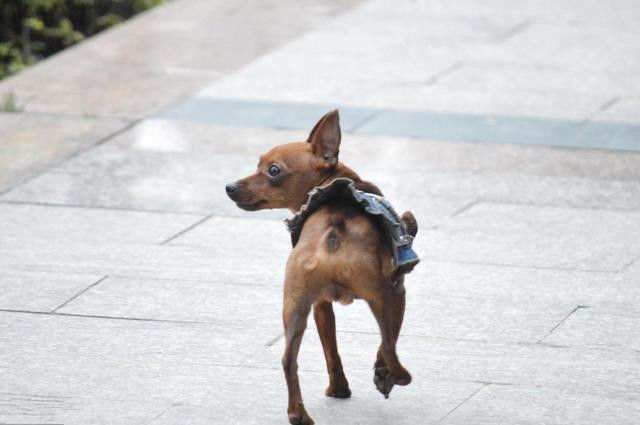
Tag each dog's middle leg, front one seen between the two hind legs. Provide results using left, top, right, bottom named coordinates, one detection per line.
left=313, top=301, right=351, bottom=398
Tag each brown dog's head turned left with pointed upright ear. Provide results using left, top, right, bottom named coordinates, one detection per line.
left=226, top=110, right=341, bottom=211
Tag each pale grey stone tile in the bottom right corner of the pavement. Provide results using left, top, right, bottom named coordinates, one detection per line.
left=442, top=385, right=640, bottom=425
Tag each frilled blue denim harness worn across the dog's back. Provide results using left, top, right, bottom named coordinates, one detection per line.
left=285, top=177, right=420, bottom=275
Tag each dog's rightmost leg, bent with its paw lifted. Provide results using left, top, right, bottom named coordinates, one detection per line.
left=369, top=277, right=411, bottom=398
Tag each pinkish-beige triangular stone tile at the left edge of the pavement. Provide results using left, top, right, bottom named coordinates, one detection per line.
left=0, top=113, right=127, bottom=192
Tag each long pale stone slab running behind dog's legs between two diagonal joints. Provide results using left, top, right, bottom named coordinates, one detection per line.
left=50, top=260, right=577, bottom=342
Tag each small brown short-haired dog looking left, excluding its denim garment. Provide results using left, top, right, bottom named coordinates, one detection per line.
left=226, top=111, right=417, bottom=424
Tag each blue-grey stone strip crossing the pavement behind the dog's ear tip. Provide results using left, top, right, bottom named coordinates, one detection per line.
left=161, top=98, right=640, bottom=150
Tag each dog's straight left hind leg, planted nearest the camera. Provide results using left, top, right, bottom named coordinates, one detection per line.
left=282, top=273, right=313, bottom=425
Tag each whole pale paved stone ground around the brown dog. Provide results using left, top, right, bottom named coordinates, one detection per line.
left=0, top=0, right=640, bottom=425
